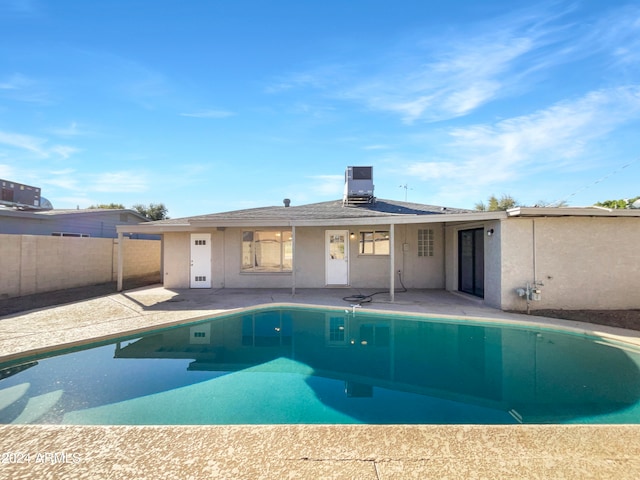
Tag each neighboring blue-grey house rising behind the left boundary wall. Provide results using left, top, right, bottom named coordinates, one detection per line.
left=0, top=206, right=158, bottom=239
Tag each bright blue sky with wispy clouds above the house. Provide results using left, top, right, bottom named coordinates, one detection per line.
left=0, top=0, right=640, bottom=218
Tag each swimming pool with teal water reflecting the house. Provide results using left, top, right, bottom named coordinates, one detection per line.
left=0, top=308, right=640, bottom=425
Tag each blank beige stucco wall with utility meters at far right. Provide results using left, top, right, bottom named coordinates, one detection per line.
left=501, top=217, right=640, bottom=311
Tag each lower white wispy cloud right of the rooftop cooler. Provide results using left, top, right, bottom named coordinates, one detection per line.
left=408, top=86, right=640, bottom=187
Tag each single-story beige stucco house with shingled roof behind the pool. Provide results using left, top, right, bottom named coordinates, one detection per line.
left=116, top=199, right=640, bottom=311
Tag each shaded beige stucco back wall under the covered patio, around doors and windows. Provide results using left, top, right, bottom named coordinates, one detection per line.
left=163, top=224, right=444, bottom=289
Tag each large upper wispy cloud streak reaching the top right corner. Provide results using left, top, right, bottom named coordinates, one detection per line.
left=268, top=3, right=640, bottom=124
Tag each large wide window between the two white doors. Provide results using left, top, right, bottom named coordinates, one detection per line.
left=241, top=230, right=293, bottom=273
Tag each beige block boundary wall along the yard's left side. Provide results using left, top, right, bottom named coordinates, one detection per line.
left=0, top=235, right=160, bottom=298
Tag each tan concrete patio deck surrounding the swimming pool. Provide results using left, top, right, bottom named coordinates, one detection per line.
left=0, top=287, right=640, bottom=479
